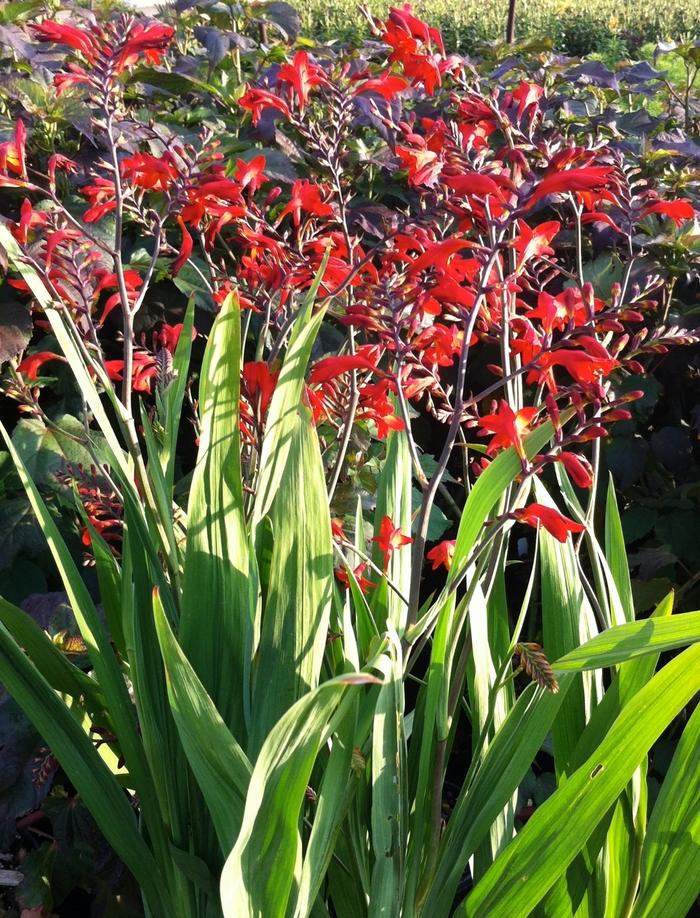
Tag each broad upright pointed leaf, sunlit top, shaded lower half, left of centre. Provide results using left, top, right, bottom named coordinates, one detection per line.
left=178, top=295, right=256, bottom=737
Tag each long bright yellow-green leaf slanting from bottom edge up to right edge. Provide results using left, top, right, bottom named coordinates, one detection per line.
left=458, top=648, right=700, bottom=918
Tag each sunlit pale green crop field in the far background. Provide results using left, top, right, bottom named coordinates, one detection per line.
left=294, top=0, right=700, bottom=55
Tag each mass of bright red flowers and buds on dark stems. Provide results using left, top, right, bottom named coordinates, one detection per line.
left=0, top=5, right=695, bottom=574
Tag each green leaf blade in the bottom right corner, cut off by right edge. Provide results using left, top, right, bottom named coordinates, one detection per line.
left=632, top=707, right=700, bottom=918
